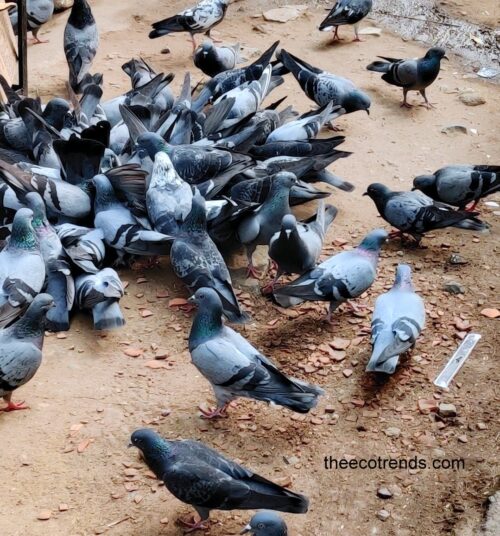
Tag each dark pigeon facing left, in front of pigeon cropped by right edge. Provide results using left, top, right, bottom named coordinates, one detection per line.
left=363, top=183, right=487, bottom=244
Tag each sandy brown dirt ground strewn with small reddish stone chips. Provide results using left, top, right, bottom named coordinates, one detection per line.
left=0, top=0, right=500, bottom=536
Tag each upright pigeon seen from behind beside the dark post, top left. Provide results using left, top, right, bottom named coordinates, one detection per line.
left=64, top=0, right=99, bottom=93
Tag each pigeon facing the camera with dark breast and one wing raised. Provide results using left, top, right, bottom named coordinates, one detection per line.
left=264, top=201, right=337, bottom=292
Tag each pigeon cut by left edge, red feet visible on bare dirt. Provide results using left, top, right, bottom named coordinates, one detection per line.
left=0, top=294, right=54, bottom=412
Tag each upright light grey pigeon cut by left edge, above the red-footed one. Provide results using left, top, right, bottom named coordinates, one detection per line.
left=0, top=208, right=45, bottom=328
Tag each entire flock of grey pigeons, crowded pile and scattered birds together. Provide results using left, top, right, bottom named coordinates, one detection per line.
left=0, top=0, right=500, bottom=536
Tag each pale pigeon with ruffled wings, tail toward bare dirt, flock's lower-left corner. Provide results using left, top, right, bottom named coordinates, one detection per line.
left=75, top=268, right=125, bottom=331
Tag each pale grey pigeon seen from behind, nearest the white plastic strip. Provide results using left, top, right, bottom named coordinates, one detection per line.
left=366, top=264, right=425, bottom=374
